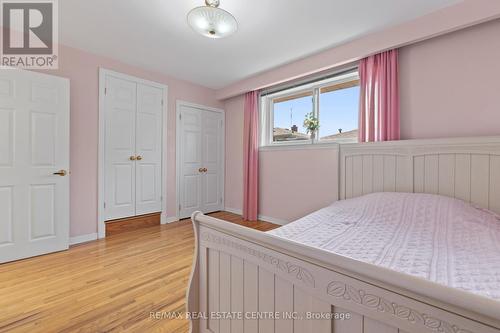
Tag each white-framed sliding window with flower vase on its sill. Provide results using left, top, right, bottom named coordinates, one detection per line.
left=261, top=70, right=359, bottom=146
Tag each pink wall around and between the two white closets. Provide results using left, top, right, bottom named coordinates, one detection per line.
left=46, top=46, right=223, bottom=236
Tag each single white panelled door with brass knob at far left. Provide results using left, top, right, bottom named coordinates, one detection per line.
left=0, top=69, right=70, bottom=262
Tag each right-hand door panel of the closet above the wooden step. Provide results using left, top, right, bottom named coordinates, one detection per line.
left=135, top=84, right=163, bottom=215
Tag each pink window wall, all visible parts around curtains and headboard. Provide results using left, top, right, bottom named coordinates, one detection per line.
left=225, top=19, right=500, bottom=221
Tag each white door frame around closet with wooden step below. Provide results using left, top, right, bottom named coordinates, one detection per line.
left=97, top=67, right=168, bottom=238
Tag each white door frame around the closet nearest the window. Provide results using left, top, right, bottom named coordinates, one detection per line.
left=175, top=100, right=226, bottom=220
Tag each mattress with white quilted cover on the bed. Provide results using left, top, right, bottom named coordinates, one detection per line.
left=268, top=193, right=500, bottom=300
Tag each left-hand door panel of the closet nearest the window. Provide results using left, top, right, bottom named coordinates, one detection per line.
left=178, top=106, right=203, bottom=218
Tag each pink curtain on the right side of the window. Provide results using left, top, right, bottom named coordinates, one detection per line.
left=359, top=50, right=400, bottom=142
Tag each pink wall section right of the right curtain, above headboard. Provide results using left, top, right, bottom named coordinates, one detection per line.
left=400, top=20, right=500, bottom=139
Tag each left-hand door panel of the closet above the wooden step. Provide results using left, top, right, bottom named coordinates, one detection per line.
left=105, top=76, right=137, bottom=220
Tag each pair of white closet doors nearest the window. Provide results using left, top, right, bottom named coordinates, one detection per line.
left=178, top=105, right=224, bottom=218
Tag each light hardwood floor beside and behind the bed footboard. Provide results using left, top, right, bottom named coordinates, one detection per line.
left=0, top=212, right=278, bottom=333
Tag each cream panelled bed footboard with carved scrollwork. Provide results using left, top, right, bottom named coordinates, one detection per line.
left=187, top=213, right=500, bottom=333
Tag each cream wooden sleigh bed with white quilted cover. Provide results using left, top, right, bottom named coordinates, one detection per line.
left=188, top=137, right=500, bottom=333
